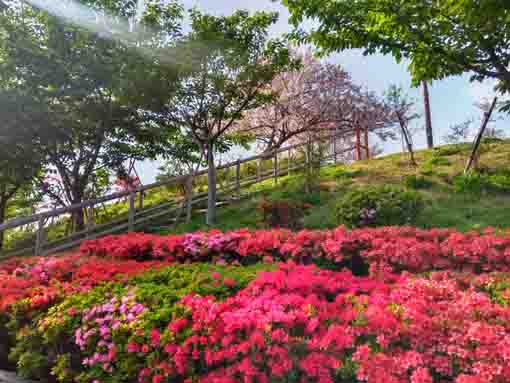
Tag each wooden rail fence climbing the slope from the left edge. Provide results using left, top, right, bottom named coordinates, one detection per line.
left=0, top=135, right=353, bottom=259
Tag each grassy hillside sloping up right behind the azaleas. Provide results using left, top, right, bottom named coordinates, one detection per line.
left=148, top=140, right=510, bottom=233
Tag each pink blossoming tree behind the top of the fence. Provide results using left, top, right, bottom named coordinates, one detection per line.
left=240, top=51, right=396, bottom=152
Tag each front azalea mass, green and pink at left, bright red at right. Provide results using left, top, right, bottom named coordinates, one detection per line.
left=5, top=263, right=510, bottom=383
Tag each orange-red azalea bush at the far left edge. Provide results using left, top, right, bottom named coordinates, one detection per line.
left=0, top=254, right=172, bottom=368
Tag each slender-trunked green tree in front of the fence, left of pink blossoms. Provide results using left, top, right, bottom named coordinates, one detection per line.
left=161, top=10, right=289, bottom=224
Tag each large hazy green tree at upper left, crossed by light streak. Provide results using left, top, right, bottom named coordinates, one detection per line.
left=0, top=0, right=180, bottom=229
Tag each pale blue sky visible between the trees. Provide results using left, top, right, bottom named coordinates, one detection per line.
left=139, top=0, right=510, bottom=183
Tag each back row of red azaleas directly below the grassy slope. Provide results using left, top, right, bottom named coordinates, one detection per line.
left=81, top=227, right=510, bottom=274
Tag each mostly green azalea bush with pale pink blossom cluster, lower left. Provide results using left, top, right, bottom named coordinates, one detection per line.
left=9, top=264, right=271, bottom=382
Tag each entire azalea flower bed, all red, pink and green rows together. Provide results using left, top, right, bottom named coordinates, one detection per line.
left=0, top=227, right=510, bottom=383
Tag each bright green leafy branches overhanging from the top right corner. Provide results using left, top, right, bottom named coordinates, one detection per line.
left=283, top=0, right=510, bottom=104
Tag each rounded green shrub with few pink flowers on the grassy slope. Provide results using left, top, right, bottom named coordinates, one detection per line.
left=337, top=186, right=424, bottom=227
